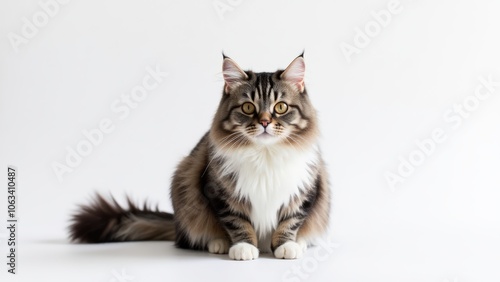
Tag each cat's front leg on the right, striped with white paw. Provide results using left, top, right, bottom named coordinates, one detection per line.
left=271, top=214, right=307, bottom=259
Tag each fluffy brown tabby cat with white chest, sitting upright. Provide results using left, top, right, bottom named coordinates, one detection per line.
left=70, top=54, right=330, bottom=260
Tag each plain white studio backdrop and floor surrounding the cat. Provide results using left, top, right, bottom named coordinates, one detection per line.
left=0, top=0, right=500, bottom=282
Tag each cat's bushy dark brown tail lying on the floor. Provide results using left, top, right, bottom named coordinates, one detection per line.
left=69, top=194, right=175, bottom=243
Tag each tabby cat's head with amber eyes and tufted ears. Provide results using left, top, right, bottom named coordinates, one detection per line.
left=211, top=55, right=318, bottom=150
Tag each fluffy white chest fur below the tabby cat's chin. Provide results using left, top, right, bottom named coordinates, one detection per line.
left=218, top=146, right=318, bottom=241
